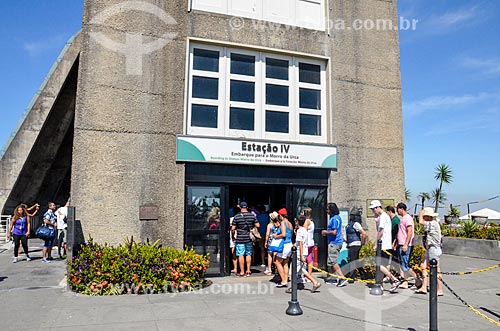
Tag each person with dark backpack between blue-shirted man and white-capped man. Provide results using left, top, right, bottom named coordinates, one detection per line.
left=345, top=207, right=366, bottom=282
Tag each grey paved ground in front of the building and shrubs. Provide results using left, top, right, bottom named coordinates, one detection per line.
left=0, top=240, right=500, bottom=331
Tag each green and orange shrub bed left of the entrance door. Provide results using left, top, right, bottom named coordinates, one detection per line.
left=68, top=238, right=209, bottom=295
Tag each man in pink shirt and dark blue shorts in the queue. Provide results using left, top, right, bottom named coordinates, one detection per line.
left=396, top=202, right=417, bottom=288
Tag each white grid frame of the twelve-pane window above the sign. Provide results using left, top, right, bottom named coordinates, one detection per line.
left=185, top=42, right=328, bottom=143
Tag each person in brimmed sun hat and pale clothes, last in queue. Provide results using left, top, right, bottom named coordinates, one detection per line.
left=415, top=207, right=443, bottom=296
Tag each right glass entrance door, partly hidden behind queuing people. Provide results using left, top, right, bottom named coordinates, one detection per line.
left=292, top=186, right=328, bottom=269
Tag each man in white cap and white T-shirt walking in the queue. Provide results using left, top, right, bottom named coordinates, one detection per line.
left=369, top=200, right=402, bottom=292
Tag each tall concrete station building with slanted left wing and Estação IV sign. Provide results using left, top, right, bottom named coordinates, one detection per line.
left=0, top=0, right=404, bottom=274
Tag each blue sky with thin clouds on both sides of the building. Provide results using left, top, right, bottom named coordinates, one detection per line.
left=0, top=0, right=500, bottom=214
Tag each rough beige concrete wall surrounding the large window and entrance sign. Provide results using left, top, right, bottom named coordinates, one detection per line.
left=72, top=0, right=404, bottom=247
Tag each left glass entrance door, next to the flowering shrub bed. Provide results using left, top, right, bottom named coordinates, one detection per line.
left=184, top=185, right=227, bottom=275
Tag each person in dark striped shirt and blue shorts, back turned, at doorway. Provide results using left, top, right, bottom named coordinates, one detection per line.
left=231, top=201, right=260, bottom=277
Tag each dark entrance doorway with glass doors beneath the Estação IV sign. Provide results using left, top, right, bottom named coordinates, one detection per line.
left=184, top=164, right=329, bottom=276
